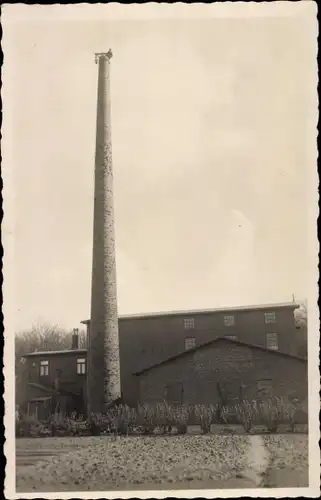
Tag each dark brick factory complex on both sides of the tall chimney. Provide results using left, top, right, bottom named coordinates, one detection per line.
left=20, top=302, right=307, bottom=414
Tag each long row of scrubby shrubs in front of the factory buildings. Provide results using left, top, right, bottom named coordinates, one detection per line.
left=16, top=397, right=304, bottom=436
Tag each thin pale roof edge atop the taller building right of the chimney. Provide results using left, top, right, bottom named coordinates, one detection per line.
left=81, top=302, right=300, bottom=325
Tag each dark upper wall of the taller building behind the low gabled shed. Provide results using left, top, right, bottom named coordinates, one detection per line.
left=119, top=307, right=296, bottom=405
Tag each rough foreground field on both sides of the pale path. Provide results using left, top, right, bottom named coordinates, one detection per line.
left=16, top=434, right=308, bottom=492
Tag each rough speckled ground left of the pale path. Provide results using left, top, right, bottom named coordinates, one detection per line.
left=17, top=435, right=250, bottom=492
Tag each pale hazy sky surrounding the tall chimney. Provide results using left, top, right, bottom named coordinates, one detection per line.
left=7, top=7, right=314, bottom=330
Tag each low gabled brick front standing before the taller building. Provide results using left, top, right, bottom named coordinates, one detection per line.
left=138, top=340, right=308, bottom=405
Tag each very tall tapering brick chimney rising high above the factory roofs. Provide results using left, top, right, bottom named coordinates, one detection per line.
left=87, top=50, right=121, bottom=415
